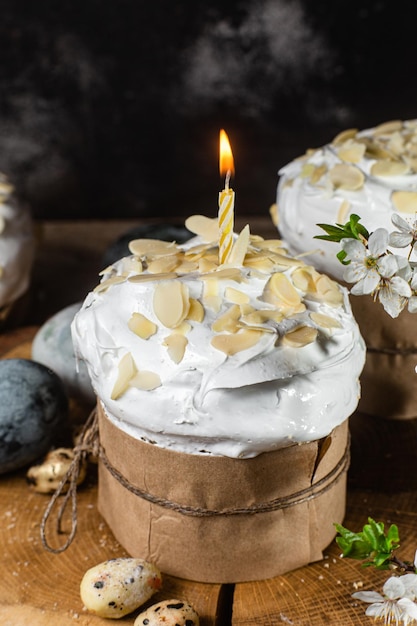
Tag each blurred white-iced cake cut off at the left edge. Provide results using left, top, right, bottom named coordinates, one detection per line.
left=0, top=173, right=34, bottom=325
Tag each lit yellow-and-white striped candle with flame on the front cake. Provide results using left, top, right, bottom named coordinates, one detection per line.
left=218, top=130, right=235, bottom=264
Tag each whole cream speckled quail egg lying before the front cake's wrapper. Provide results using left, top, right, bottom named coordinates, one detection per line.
left=80, top=557, right=162, bottom=619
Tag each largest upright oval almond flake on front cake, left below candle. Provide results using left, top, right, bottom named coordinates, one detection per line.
left=153, top=281, right=190, bottom=328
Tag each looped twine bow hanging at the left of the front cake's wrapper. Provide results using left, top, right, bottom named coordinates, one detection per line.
left=40, top=409, right=99, bottom=554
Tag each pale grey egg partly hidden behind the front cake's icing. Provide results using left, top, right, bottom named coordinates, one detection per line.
left=32, top=302, right=95, bottom=404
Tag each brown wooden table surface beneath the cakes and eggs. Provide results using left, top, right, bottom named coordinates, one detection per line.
left=0, top=217, right=417, bottom=626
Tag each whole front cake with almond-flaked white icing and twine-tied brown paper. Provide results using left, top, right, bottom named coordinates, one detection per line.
left=72, top=216, right=365, bottom=582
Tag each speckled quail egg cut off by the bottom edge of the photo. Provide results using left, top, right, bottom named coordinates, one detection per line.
left=133, top=600, right=200, bottom=626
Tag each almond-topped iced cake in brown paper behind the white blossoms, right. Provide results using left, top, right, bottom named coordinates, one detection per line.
left=277, top=120, right=417, bottom=419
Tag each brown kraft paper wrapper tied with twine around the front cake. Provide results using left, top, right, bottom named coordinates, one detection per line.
left=98, top=402, right=349, bottom=583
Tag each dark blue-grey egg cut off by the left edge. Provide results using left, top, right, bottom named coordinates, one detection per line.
left=0, top=359, right=68, bottom=474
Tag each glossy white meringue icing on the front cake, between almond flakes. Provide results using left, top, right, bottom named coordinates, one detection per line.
left=72, top=222, right=365, bottom=458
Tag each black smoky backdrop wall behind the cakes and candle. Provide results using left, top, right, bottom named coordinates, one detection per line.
left=0, top=0, right=417, bottom=220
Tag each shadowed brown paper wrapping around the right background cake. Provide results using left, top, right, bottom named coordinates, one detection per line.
left=350, top=296, right=417, bottom=419
